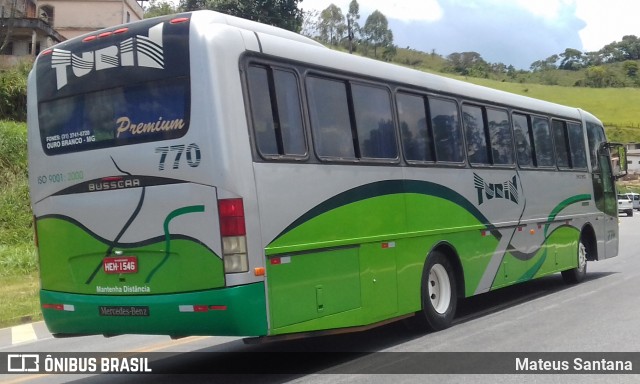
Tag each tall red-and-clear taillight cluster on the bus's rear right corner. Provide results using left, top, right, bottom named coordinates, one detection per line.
left=218, top=199, right=249, bottom=273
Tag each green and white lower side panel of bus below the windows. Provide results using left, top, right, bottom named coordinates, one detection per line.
left=254, top=163, right=596, bottom=334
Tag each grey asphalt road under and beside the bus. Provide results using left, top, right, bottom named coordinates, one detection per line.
left=0, top=213, right=640, bottom=384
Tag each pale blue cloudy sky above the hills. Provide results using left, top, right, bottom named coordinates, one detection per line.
left=298, top=0, right=640, bottom=70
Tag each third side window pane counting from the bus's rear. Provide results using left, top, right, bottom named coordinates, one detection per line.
left=307, top=76, right=356, bottom=159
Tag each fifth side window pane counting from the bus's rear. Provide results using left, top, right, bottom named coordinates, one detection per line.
left=397, top=93, right=435, bottom=161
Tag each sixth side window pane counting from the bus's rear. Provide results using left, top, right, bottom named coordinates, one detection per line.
left=429, top=97, right=464, bottom=163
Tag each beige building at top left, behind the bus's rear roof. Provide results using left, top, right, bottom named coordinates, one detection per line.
left=38, top=0, right=144, bottom=39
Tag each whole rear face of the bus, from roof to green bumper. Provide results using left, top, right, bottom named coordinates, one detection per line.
left=29, top=15, right=267, bottom=336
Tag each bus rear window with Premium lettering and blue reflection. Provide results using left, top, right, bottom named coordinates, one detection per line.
left=39, top=77, right=190, bottom=155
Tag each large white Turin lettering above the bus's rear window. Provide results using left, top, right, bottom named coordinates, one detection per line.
left=51, top=23, right=164, bottom=89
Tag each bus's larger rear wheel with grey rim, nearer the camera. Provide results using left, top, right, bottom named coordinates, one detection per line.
left=408, top=251, right=458, bottom=331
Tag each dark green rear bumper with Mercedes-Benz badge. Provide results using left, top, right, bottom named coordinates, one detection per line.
left=40, top=283, right=267, bottom=336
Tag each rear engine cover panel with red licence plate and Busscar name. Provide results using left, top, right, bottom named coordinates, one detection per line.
left=34, top=183, right=225, bottom=295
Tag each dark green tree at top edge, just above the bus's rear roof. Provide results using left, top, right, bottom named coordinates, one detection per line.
left=208, top=0, right=303, bottom=32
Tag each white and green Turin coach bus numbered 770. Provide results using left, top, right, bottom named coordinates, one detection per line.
left=28, top=11, right=626, bottom=340
